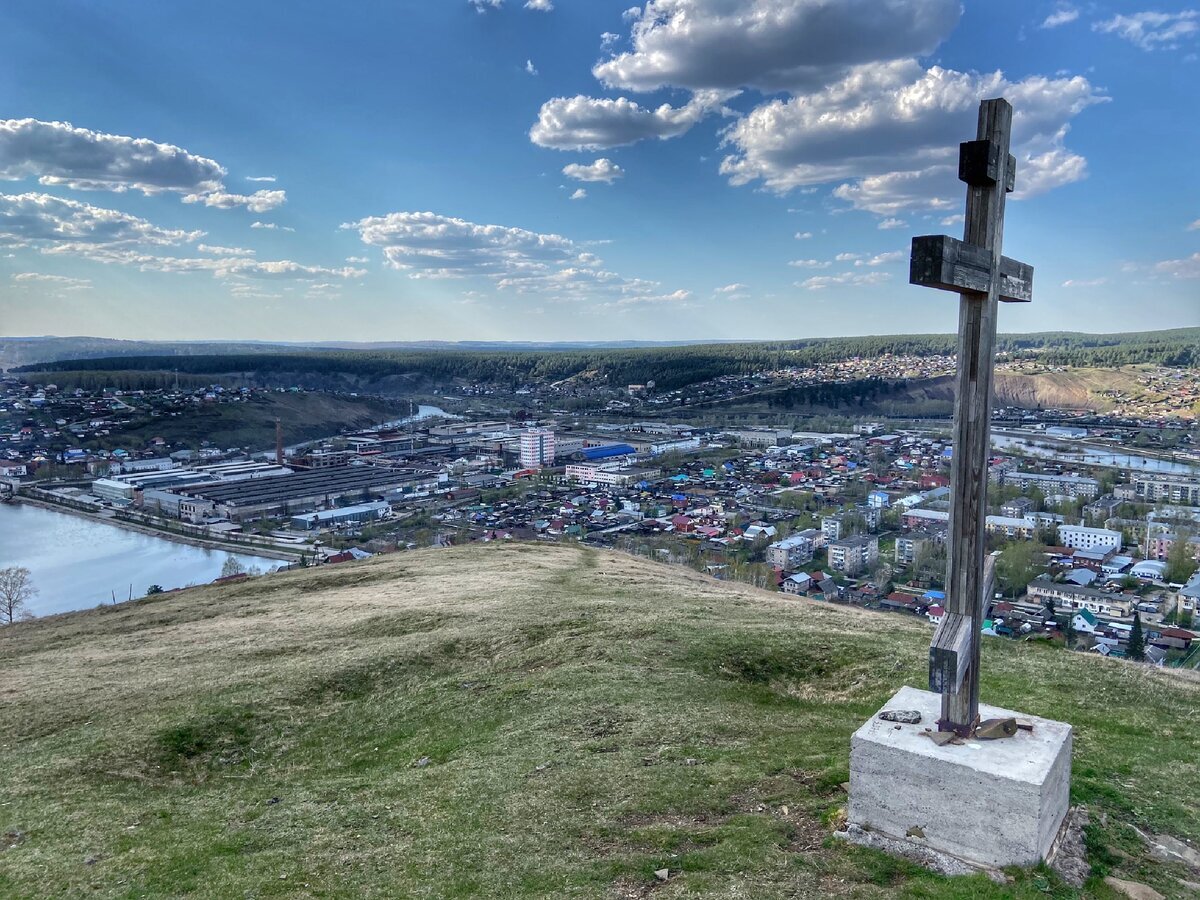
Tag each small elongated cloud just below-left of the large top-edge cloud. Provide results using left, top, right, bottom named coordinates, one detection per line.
left=529, top=91, right=731, bottom=150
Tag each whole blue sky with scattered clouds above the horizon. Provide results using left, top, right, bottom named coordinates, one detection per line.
left=0, top=0, right=1200, bottom=341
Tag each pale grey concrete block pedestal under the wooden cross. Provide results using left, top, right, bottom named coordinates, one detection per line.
left=848, top=688, right=1072, bottom=868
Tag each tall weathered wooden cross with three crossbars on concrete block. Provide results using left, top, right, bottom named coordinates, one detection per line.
left=908, top=98, right=1033, bottom=737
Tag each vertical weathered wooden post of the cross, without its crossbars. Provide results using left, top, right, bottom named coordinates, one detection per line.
left=938, top=100, right=1013, bottom=734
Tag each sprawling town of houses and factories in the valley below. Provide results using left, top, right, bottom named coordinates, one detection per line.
left=0, top=372, right=1200, bottom=667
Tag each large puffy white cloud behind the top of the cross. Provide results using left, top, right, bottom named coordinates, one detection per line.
left=721, top=60, right=1106, bottom=209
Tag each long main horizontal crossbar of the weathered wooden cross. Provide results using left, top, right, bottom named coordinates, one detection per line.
left=908, top=234, right=1033, bottom=304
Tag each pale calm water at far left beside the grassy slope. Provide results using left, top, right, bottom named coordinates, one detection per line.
left=0, top=503, right=280, bottom=616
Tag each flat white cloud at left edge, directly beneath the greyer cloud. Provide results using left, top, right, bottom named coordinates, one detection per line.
left=0, top=193, right=204, bottom=247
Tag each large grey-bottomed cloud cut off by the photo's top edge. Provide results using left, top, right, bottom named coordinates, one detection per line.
left=592, top=0, right=961, bottom=91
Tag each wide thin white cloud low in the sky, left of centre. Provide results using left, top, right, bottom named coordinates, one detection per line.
left=342, top=212, right=686, bottom=301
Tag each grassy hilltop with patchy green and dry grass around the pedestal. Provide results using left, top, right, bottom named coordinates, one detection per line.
left=0, top=545, right=1200, bottom=900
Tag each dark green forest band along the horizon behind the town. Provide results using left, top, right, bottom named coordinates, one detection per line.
left=11, top=328, right=1200, bottom=390
